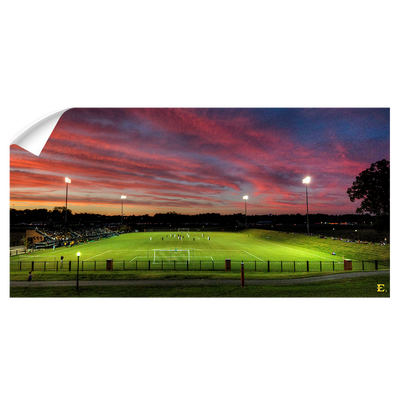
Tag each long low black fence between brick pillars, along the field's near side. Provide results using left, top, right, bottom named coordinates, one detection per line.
left=7, top=260, right=393, bottom=272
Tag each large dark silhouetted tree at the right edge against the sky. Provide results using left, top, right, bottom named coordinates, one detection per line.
left=347, top=159, right=393, bottom=230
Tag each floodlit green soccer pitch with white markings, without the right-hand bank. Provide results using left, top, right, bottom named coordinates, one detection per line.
left=12, top=231, right=335, bottom=263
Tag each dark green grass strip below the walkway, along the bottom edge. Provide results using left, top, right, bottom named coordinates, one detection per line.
left=7, top=276, right=392, bottom=300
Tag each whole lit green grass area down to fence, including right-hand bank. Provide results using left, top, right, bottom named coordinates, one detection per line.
left=7, top=229, right=393, bottom=272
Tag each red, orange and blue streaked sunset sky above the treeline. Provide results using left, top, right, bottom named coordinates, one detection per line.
left=7, top=105, right=392, bottom=215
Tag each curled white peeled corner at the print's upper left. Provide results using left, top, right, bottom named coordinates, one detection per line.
left=7, top=105, right=75, bottom=156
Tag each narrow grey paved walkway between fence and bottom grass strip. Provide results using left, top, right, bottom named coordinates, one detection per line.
left=7, top=270, right=393, bottom=287
